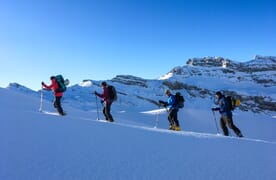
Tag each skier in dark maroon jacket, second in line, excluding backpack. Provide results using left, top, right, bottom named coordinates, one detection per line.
left=94, top=82, right=114, bottom=122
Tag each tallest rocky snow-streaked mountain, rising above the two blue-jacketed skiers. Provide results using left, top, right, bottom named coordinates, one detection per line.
left=161, top=56, right=276, bottom=113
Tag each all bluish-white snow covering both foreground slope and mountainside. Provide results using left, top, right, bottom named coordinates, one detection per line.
left=0, top=56, right=276, bottom=180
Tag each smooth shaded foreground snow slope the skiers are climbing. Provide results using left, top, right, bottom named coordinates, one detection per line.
left=0, top=88, right=276, bottom=180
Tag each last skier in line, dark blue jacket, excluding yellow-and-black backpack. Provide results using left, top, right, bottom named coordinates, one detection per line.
left=211, top=91, right=243, bottom=137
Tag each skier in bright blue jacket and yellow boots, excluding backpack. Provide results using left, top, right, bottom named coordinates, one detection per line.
left=159, top=90, right=181, bottom=131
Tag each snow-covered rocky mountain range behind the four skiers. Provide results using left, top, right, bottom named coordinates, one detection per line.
left=9, top=55, right=276, bottom=114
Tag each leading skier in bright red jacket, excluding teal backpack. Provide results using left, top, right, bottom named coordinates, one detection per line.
left=41, top=76, right=66, bottom=116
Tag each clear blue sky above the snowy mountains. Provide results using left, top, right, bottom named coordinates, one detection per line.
left=0, top=0, right=276, bottom=90
